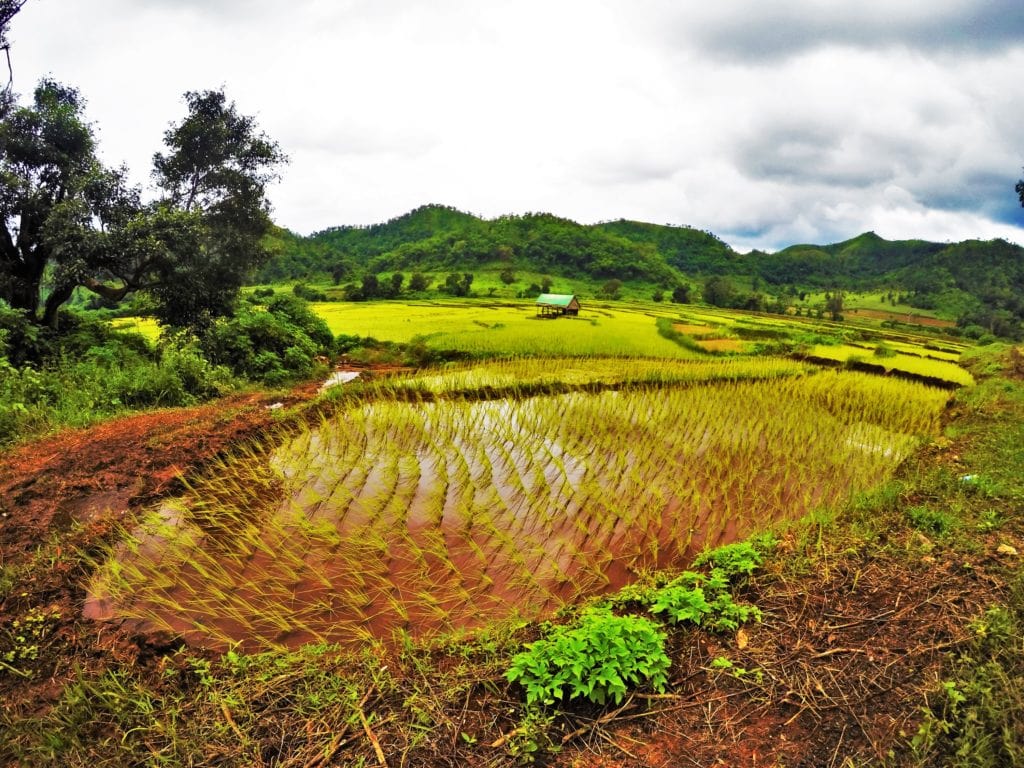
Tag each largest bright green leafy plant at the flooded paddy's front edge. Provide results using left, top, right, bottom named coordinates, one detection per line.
left=506, top=606, right=670, bottom=706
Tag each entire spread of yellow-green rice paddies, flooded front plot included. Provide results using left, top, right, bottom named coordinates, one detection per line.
left=81, top=301, right=971, bottom=650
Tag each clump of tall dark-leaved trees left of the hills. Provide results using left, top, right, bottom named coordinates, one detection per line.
left=0, top=81, right=285, bottom=327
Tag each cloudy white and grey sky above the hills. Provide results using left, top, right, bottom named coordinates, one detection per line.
left=10, top=0, right=1024, bottom=250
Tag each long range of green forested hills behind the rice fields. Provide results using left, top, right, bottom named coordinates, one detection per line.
left=258, top=205, right=1024, bottom=335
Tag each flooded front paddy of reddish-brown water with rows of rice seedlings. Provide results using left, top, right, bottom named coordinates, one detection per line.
left=87, top=384, right=909, bottom=649
